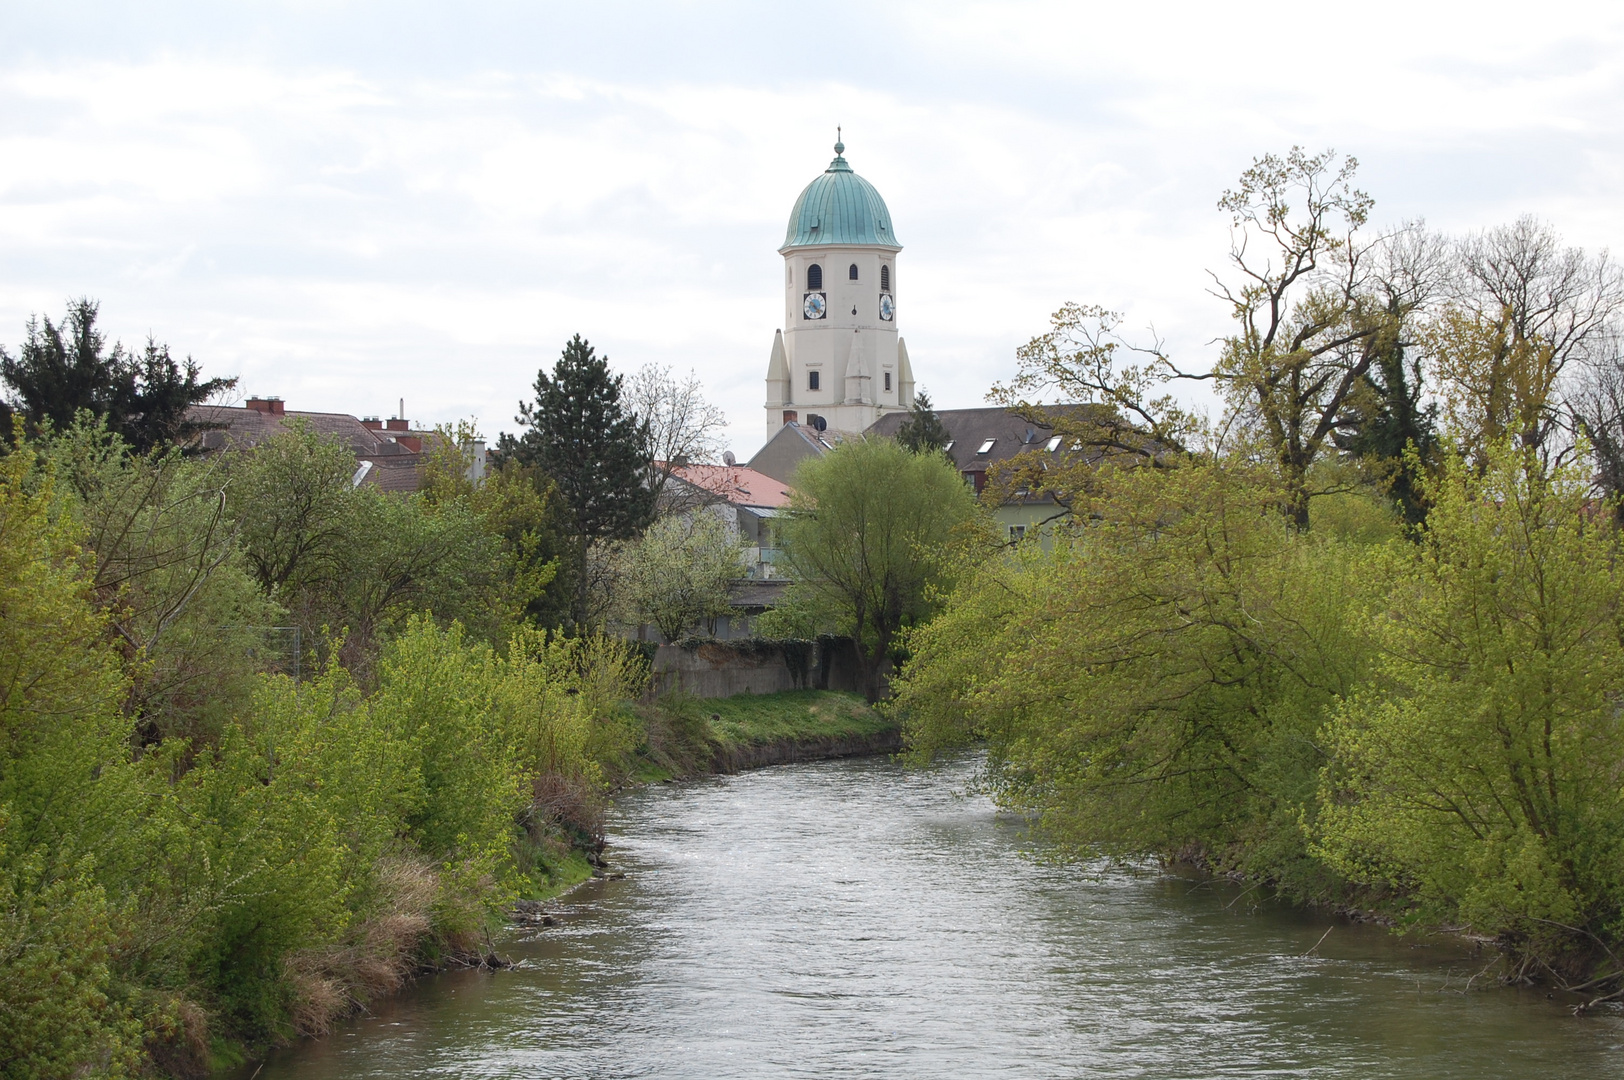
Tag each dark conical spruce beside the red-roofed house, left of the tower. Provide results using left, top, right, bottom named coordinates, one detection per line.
left=500, top=335, right=654, bottom=544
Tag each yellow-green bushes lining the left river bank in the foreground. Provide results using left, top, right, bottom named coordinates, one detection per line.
left=0, top=428, right=646, bottom=1080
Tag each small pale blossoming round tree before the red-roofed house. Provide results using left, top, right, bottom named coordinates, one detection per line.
left=619, top=510, right=744, bottom=642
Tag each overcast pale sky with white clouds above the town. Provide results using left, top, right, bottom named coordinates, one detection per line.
left=0, top=0, right=1624, bottom=456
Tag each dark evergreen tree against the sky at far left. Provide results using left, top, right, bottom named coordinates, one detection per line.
left=0, top=299, right=237, bottom=453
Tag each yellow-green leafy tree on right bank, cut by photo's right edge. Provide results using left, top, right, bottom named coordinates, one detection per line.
left=1317, top=443, right=1624, bottom=939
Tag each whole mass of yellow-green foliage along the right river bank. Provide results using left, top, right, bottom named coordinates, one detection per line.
left=892, top=443, right=1624, bottom=963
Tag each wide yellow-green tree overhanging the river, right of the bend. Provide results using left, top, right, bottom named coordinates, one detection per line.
left=892, top=454, right=1371, bottom=887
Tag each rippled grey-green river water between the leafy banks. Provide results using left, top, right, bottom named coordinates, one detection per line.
left=260, top=760, right=1624, bottom=1080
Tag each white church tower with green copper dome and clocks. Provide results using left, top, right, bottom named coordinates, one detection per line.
left=767, top=141, right=914, bottom=438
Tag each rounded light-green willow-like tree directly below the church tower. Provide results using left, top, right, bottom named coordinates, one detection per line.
left=765, top=438, right=976, bottom=700
